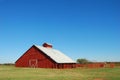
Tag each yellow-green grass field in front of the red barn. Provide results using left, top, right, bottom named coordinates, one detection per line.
left=0, top=66, right=120, bottom=80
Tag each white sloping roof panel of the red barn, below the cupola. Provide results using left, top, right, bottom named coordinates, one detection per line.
left=35, top=45, right=75, bottom=63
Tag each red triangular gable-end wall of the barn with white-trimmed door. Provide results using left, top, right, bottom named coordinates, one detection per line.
left=15, top=47, right=56, bottom=68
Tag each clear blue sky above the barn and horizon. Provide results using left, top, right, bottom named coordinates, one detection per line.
left=0, top=0, right=120, bottom=63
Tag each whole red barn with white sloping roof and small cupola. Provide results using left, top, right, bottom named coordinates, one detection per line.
left=15, top=43, right=76, bottom=68
